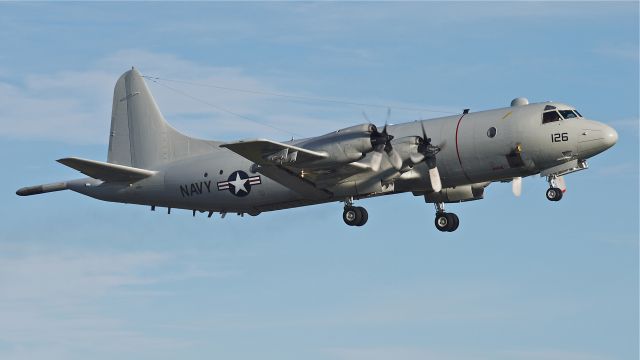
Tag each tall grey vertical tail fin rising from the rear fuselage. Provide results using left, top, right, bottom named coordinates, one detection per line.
left=107, top=68, right=219, bottom=169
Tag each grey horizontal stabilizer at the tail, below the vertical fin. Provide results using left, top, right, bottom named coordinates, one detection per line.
left=58, top=158, right=156, bottom=182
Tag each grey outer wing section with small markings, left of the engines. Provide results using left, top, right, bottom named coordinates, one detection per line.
left=220, top=139, right=327, bottom=165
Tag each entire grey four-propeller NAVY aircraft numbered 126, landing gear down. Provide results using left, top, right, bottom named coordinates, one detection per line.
left=16, top=68, right=618, bottom=232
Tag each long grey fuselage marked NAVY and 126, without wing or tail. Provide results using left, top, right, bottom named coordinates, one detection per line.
left=68, top=102, right=617, bottom=214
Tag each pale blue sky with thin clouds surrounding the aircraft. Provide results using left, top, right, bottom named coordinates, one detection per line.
left=0, top=2, right=639, bottom=360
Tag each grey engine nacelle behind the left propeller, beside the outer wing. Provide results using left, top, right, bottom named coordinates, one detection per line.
left=296, top=124, right=376, bottom=168
